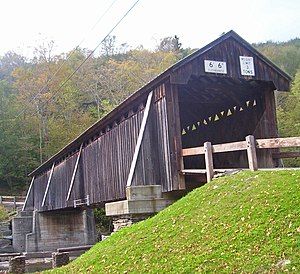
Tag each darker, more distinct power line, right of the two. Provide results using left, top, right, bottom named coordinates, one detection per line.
left=38, top=0, right=140, bottom=111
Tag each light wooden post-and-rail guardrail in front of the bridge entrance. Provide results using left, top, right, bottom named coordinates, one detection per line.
left=182, top=135, right=300, bottom=182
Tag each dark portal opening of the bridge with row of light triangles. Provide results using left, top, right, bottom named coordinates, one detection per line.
left=178, top=76, right=277, bottom=184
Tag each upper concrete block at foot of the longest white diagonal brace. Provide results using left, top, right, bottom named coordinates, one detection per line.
left=126, top=185, right=162, bottom=200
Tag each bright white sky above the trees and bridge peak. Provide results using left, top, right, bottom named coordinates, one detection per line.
left=0, top=0, right=300, bottom=56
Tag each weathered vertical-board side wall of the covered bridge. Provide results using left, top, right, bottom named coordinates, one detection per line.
left=28, top=84, right=178, bottom=211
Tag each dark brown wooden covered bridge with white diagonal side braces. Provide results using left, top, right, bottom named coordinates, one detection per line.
left=16, top=31, right=298, bottom=252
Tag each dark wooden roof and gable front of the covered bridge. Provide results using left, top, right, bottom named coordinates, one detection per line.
left=29, top=31, right=291, bottom=176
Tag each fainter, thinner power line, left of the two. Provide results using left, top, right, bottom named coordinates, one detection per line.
left=16, top=0, right=117, bottom=118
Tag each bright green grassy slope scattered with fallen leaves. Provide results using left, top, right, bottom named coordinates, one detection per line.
left=47, top=171, right=300, bottom=273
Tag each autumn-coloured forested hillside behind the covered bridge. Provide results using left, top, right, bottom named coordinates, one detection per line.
left=0, top=36, right=300, bottom=193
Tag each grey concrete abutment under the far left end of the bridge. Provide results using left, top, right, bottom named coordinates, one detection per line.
left=13, top=208, right=96, bottom=252
